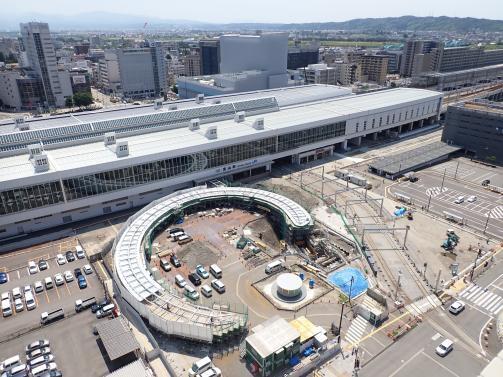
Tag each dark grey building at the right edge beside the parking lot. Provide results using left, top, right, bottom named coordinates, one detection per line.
left=442, top=99, right=503, bottom=165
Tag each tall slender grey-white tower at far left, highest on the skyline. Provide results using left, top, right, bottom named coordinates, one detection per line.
left=20, top=22, right=67, bottom=107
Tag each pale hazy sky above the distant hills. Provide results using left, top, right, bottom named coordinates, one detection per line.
left=0, top=0, right=503, bottom=23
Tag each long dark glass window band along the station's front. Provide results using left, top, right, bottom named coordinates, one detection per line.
left=0, top=122, right=346, bottom=215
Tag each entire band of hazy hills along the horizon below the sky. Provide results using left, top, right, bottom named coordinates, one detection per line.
left=0, top=12, right=503, bottom=33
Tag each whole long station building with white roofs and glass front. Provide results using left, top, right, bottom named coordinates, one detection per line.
left=0, top=85, right=442, bottom=239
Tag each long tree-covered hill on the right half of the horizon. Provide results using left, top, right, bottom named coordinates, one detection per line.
left=223, top=16, right=503, bottom=33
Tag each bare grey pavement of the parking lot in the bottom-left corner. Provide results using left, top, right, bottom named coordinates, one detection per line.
left=0, top=310, right=109, bottom=377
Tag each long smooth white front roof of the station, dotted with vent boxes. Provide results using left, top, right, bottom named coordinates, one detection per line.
left=0, top=88, right=441, bottom=181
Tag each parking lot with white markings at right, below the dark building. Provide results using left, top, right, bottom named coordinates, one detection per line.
left=390, top=161, right=503, bottom=238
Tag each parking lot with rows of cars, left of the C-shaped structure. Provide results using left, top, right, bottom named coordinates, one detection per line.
left=0, top=239, right=104, bottom=340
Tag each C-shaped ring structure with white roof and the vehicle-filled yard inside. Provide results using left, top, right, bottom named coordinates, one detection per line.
left=113, top=187, right=313, bottom=343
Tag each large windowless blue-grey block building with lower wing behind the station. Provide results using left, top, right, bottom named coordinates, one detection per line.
left=177, top=33, right=293, bottom=98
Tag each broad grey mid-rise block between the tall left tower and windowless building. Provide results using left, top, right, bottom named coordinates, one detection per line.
left=117, top=42, right=166, bottom=99
